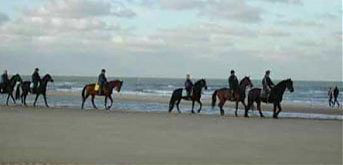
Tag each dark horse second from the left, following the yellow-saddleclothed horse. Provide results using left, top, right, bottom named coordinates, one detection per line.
left=15, top=74, right=54, bottom=107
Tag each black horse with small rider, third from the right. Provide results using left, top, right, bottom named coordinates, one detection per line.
left=169, top=79, right=207, bottom=113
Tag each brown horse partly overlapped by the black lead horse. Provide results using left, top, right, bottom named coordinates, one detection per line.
left=212, top=77, right=253, bottom=116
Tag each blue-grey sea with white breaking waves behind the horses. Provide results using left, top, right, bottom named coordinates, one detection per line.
left=0, top=76, right=343, bottom=119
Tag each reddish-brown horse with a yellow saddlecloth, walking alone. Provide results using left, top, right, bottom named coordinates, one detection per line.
left=81, top=80, right=123, bottom=110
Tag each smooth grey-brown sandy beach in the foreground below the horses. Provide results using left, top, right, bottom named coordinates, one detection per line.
left=0, top=106, right=342, bottom=164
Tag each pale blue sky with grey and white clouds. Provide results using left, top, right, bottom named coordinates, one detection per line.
left=0, top=0, right=343, bottom=81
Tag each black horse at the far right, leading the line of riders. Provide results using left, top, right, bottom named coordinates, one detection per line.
left=244, top=79, right=294, bottom=119
